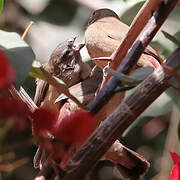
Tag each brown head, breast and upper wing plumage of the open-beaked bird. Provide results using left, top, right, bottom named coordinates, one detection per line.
left=34, top=38, right=91, bottom=107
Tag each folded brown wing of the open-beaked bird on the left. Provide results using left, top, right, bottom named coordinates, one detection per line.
left=34, top=79, right=49, bottom=106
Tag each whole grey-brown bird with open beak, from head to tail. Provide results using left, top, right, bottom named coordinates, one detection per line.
left=32, top=37, right=91, bottom=169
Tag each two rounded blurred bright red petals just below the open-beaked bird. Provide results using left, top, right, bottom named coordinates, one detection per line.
left=32, top=106, right=94, bottom=143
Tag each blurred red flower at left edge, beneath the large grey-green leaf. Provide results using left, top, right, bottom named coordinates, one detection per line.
left=0, top=51, right=15, bottom=89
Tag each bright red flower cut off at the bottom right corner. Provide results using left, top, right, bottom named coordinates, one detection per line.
left=170, top=152, right=180, bottom=180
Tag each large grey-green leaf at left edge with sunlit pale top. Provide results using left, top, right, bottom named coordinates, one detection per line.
left=0, top=30, right=35, bottom=87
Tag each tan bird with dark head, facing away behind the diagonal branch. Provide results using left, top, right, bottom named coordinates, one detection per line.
left=85, top=8, right=159, bottom=68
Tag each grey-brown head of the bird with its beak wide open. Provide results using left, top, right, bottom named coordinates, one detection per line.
left=49, top=38, right=84, bottom=86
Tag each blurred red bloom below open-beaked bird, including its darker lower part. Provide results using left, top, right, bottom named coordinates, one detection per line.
left=32, top=104, right=94, bottom=163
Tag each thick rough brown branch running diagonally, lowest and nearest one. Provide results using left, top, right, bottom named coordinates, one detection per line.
left=64, top=49, right=180, bottom=180
